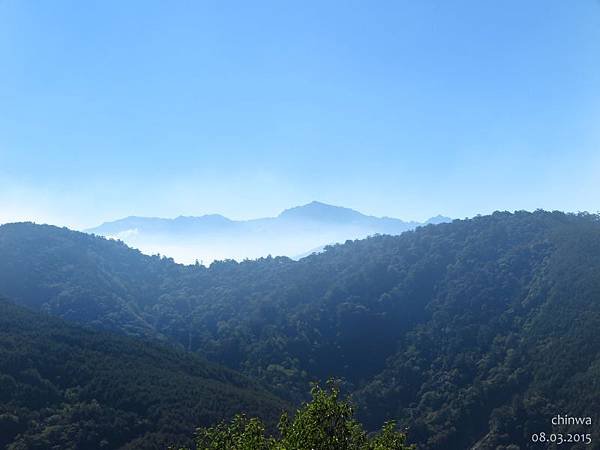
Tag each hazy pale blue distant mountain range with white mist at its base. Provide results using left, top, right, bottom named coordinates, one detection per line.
left=86, top=201, right=451, bottom=264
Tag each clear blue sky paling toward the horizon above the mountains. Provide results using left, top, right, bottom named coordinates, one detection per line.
left=0, top=0, right=600, bottom=228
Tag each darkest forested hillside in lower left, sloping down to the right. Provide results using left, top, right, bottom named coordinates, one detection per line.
left=0, top=300, right=285, bottom=450
